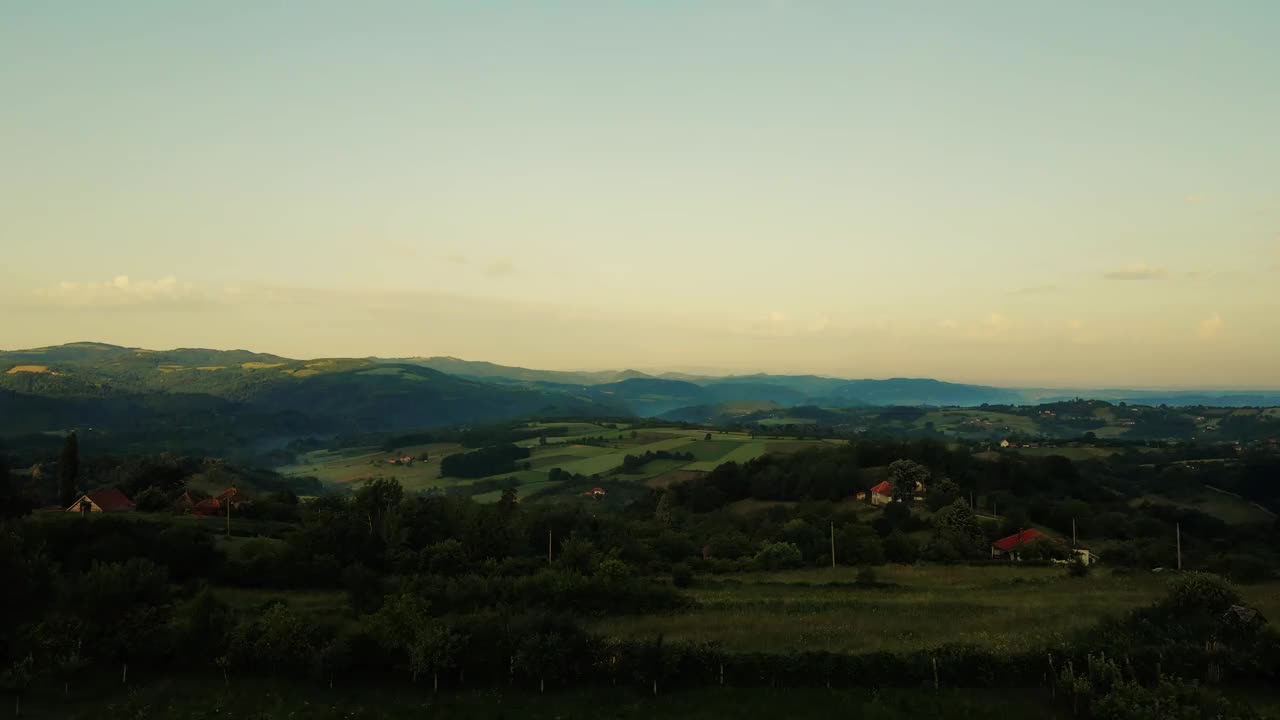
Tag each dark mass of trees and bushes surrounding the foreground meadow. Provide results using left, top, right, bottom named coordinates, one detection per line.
left=0, top=427, right=1280, bottom=720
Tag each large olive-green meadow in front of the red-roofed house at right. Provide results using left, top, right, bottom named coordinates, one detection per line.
left=595, top=566, right=1280, bottom=652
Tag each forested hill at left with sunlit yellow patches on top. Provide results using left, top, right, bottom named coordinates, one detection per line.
left=0, top=343, right=625, bottom=447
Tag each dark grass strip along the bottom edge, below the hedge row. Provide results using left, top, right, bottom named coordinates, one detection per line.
left=23, top=669, right=1070, bottom=720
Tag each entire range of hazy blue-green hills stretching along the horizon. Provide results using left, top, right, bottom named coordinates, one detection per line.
left=0, top=342, right=1280, bottom=445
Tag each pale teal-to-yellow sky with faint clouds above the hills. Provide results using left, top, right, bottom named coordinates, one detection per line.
left=0, top=0, right=1280, bottom=388
